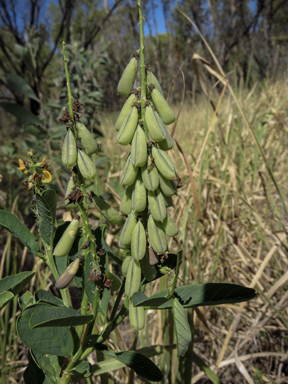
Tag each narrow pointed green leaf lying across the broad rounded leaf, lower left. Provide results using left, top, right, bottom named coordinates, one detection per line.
left=29, top=306, right=93, bottom=329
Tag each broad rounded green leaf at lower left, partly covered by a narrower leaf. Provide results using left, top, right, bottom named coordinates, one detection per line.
left=17, top=304, right=74, bottom=356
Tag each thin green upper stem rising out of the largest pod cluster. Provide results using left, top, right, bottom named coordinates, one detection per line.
left=138, top=0, right=149, bottom=141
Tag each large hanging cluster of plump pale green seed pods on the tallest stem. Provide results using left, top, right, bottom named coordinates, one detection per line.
left=115, top=52, right=180, bottom=330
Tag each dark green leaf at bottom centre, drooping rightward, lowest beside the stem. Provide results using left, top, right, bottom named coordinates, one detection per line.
left=102, top=351, right=163, bottom=381
